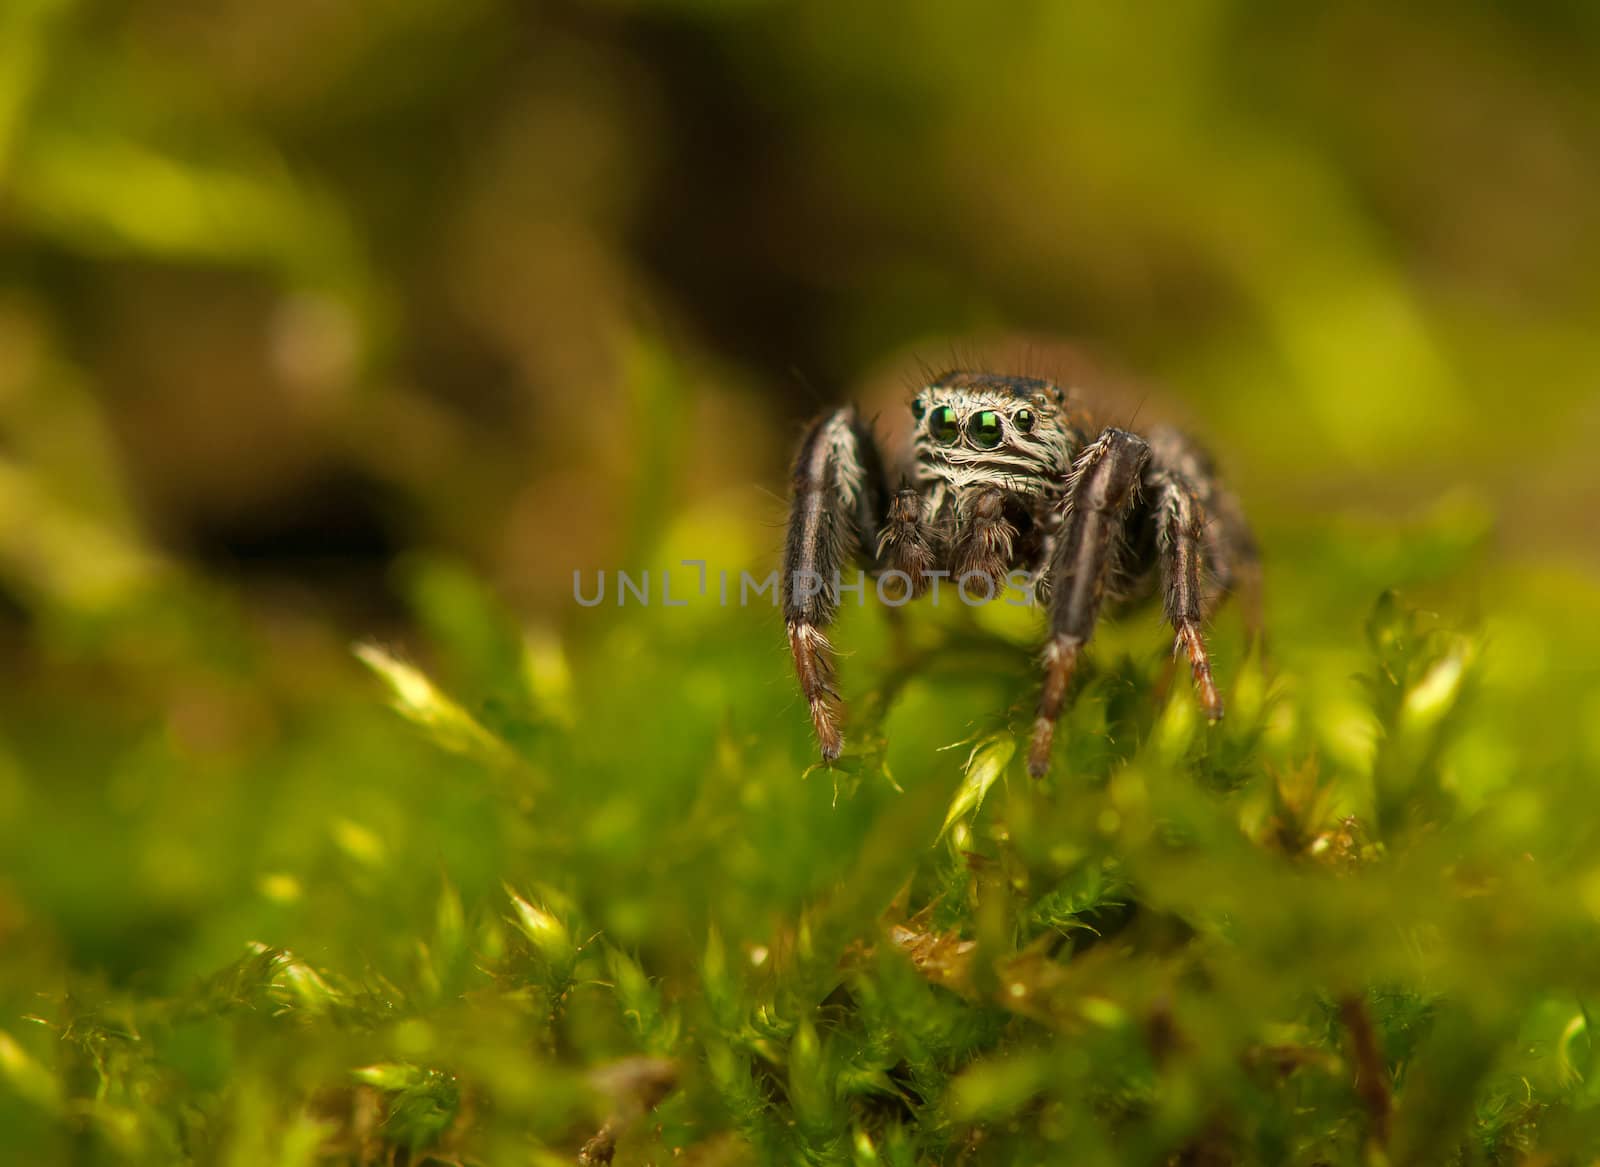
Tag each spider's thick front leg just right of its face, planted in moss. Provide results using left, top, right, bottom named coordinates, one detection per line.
left=1027, top=429, right=1150, bottom=778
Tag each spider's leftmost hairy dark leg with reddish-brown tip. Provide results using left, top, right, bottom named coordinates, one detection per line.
left=782, top=407, right=886, bottom=762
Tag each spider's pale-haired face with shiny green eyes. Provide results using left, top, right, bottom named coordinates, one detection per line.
left=910, top=373, right=1070, bottom=495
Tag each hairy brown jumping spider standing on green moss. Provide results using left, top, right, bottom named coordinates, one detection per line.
left=782, top=371, right=1259, bottom=778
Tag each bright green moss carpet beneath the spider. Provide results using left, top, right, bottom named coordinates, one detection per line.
left=0, top=352, right=1600, bottom=1164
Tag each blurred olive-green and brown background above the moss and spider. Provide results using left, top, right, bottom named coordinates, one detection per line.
left=9, top=0, right=1600, bottom=637
